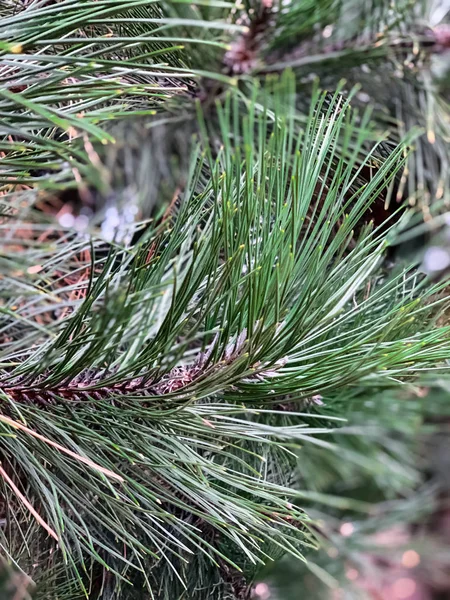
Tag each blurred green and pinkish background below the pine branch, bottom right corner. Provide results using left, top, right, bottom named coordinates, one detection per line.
left=253, top=379, right=450, bottom=600
